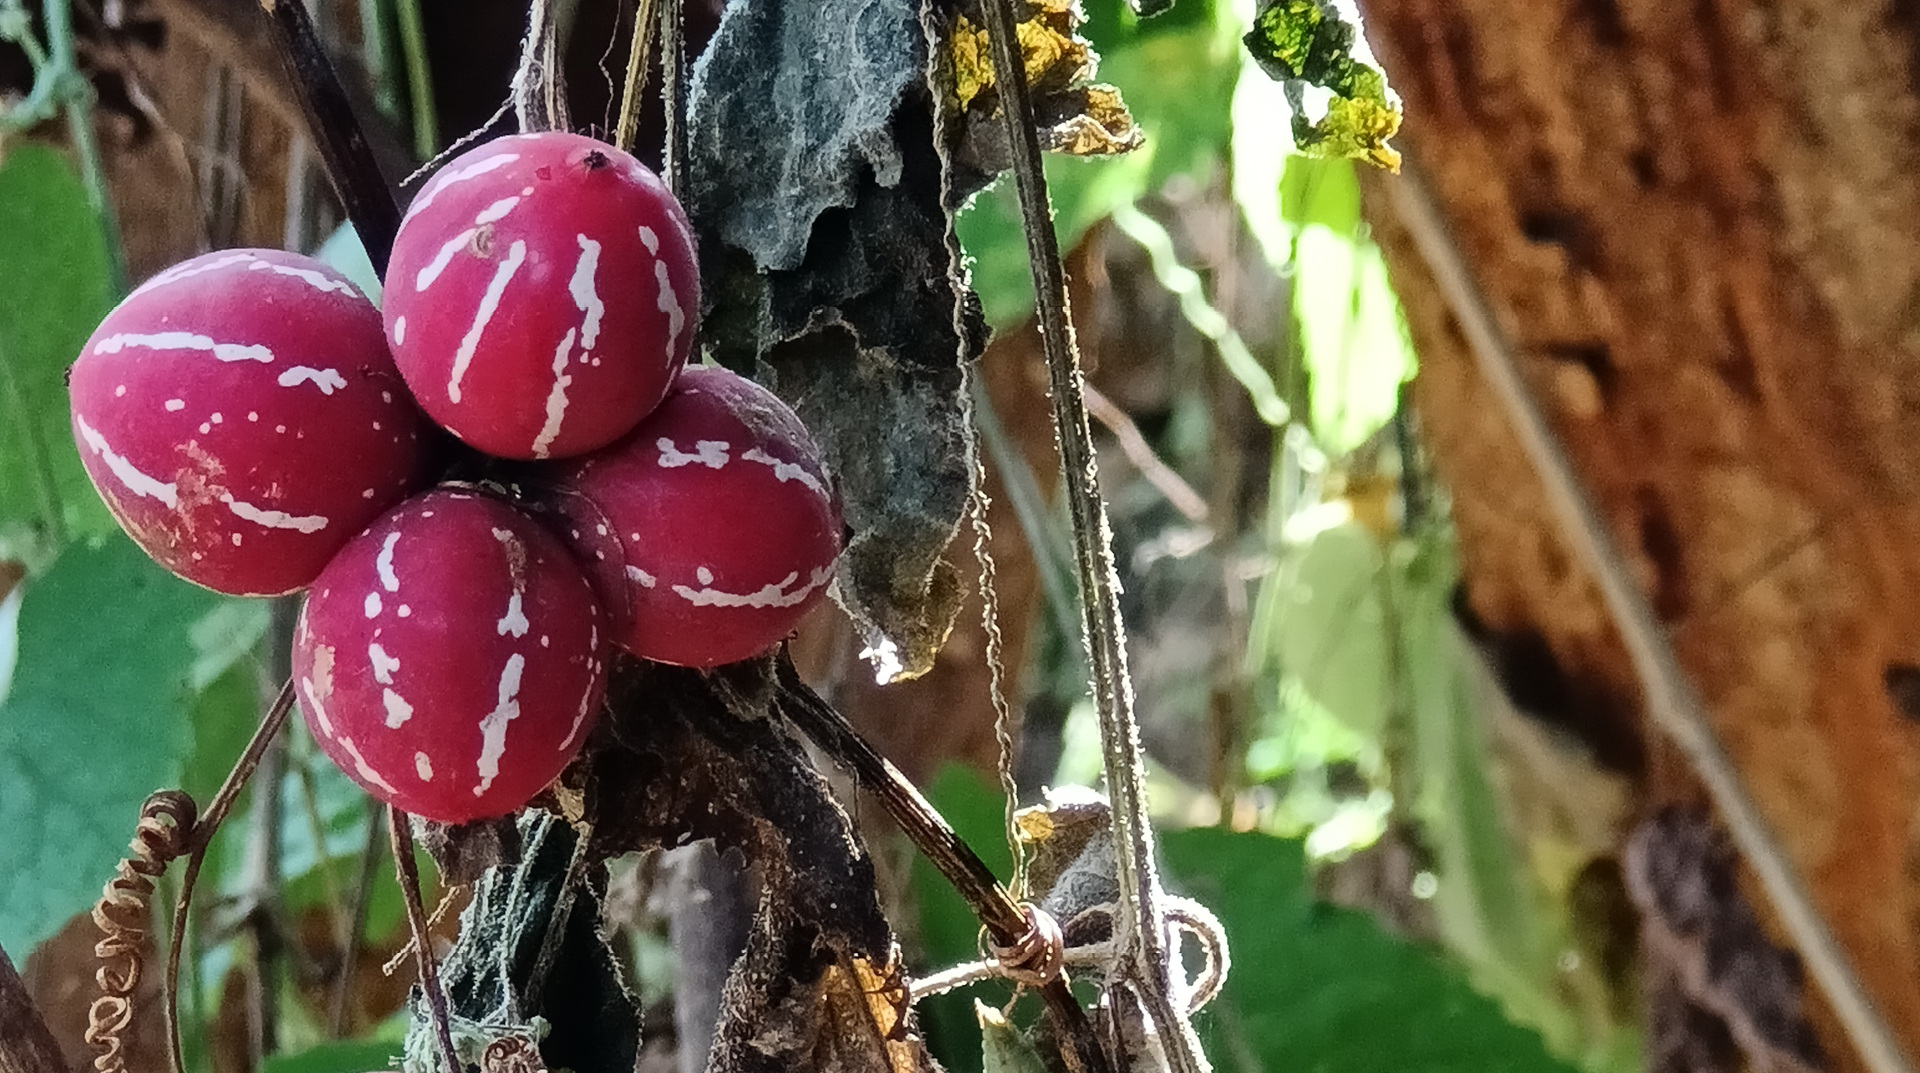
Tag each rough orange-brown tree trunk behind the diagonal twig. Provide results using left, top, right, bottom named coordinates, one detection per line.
left=1365, top=0, right=1920, bottom=1063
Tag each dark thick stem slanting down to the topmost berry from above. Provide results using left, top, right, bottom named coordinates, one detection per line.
left=259, top=0, right=399, bottom=276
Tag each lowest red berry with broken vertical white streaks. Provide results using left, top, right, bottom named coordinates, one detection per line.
left=294, top=489, right=607, bottom=823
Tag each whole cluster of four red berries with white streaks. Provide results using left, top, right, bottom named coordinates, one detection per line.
left=69, top=132, right=841, bottom=823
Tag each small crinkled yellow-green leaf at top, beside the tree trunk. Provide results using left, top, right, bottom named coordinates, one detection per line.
left=1242, top=0, right=1402, bottom=171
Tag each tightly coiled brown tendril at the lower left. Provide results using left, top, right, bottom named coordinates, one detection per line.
left=86, top=789, right=198, bottom=1073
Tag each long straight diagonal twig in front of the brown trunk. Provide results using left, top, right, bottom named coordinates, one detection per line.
left=1390, top=161, right=1912, bottom=1073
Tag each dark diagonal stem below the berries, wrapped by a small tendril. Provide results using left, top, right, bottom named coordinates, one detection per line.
left=780, top=651, right=1108, bottom=1073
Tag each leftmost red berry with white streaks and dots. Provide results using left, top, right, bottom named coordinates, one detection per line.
left=67, top=250, right=430, bottom=595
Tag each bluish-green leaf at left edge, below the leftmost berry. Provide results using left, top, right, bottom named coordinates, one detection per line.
left=0, top=537, right=225, bottom=950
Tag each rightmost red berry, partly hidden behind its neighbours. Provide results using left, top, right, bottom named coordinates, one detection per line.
left=553, top=367, right=841, bottom=666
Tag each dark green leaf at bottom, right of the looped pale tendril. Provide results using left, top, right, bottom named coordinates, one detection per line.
left=1162, top=829, right=1571, bottom=1073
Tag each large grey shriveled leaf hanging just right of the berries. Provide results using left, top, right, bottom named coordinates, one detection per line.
left=685, top=0, right=983, bottom=676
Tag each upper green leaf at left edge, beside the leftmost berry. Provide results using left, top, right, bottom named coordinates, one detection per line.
left=0, top=144, right=115, bottom=562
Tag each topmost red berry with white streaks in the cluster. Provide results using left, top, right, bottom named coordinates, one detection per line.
left=384, top=131, right=701, bottom=459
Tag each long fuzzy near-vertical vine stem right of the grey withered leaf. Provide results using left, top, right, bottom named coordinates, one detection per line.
left=981, top=0, right=1208, bottom=1073
